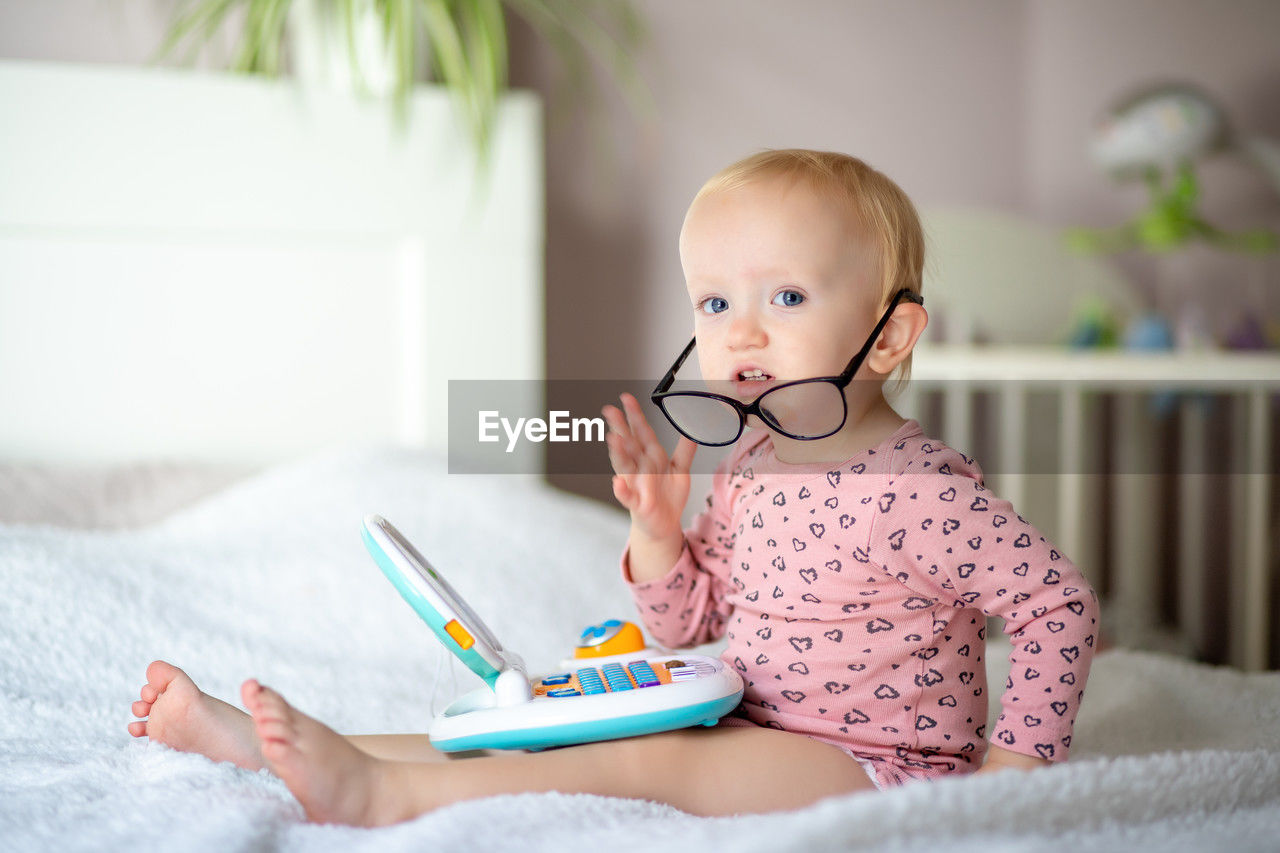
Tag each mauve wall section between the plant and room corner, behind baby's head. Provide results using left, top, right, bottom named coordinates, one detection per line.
left=501, top=0, right=1027, bottom=378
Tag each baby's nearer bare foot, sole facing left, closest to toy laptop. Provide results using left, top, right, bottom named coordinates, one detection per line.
left=241, top=680, right=413, bottom=826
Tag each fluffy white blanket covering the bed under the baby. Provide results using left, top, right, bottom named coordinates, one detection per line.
left=0, top=451, right=1280, bottom=852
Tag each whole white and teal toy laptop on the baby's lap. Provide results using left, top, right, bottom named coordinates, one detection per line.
left=362, top=515, right=742, bottom=752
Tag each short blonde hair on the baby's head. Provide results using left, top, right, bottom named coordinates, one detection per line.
left=694, top=149, right=924, bottom=393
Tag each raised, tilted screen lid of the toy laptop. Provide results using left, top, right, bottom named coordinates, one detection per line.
left=365, top=515, right=503, bottom=663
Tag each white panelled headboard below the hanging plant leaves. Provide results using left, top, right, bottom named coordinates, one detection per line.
left=0, top=61, right=543, bottom=462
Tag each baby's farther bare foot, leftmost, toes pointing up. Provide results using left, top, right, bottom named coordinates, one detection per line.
left=129, top=661, right=265, bottom=770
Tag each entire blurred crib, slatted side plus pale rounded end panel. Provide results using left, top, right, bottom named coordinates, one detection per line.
left=897, top=210, right=1280, bottom=670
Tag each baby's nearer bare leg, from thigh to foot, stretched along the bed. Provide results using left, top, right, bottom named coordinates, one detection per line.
left=242, top=681, right=874, bottom=826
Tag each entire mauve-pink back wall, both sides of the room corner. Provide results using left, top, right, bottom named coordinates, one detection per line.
left=0, top=0, right=1280, bottom=499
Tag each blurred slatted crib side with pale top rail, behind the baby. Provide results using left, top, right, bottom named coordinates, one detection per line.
left=899, top=345, right=1280, bottom=670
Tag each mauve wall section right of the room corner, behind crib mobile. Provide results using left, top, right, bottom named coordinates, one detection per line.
left=1025, top=0, right=1280, bottom=227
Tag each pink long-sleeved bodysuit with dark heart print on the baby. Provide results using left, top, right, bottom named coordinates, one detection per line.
left=622, top=420, right=1098, bottom=788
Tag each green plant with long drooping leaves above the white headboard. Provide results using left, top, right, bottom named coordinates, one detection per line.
left=157, top=0, right=645, bottom=163
